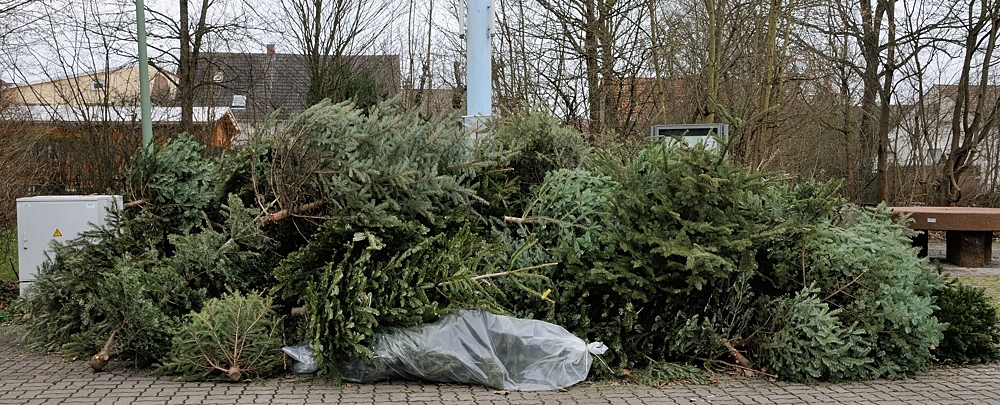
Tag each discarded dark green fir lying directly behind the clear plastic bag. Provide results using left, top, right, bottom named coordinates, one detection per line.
left=275, top=221, right=540, bottom=373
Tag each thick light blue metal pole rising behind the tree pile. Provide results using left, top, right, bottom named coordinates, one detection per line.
left=465, top=0, right=493, bottom=123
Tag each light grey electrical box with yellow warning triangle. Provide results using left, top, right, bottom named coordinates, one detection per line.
left=17, top=195, right=122, bottom=296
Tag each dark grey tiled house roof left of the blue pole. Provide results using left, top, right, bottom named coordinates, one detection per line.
left=195, top=49, right=400, bottom=122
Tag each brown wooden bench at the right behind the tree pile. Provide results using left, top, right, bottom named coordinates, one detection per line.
left=889, top=207, right=1000, bottom=267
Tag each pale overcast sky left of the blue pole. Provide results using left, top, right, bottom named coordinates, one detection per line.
left=0, top=0, right=459, bottom=84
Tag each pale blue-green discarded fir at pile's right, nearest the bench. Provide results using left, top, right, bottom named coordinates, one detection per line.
left=761, top=206, right=944, bottom=378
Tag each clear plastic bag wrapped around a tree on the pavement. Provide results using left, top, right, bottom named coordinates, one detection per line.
left=340, top=311, right=607, bottom=391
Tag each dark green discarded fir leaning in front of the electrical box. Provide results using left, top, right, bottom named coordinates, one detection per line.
left=25, top=234, right=188, bottom=364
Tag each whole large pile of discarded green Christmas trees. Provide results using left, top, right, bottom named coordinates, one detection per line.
left=17, top=102, right=998, bottom=381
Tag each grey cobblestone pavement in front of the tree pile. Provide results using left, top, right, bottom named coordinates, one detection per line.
left=0, top=326, right=1000, bottom=405
